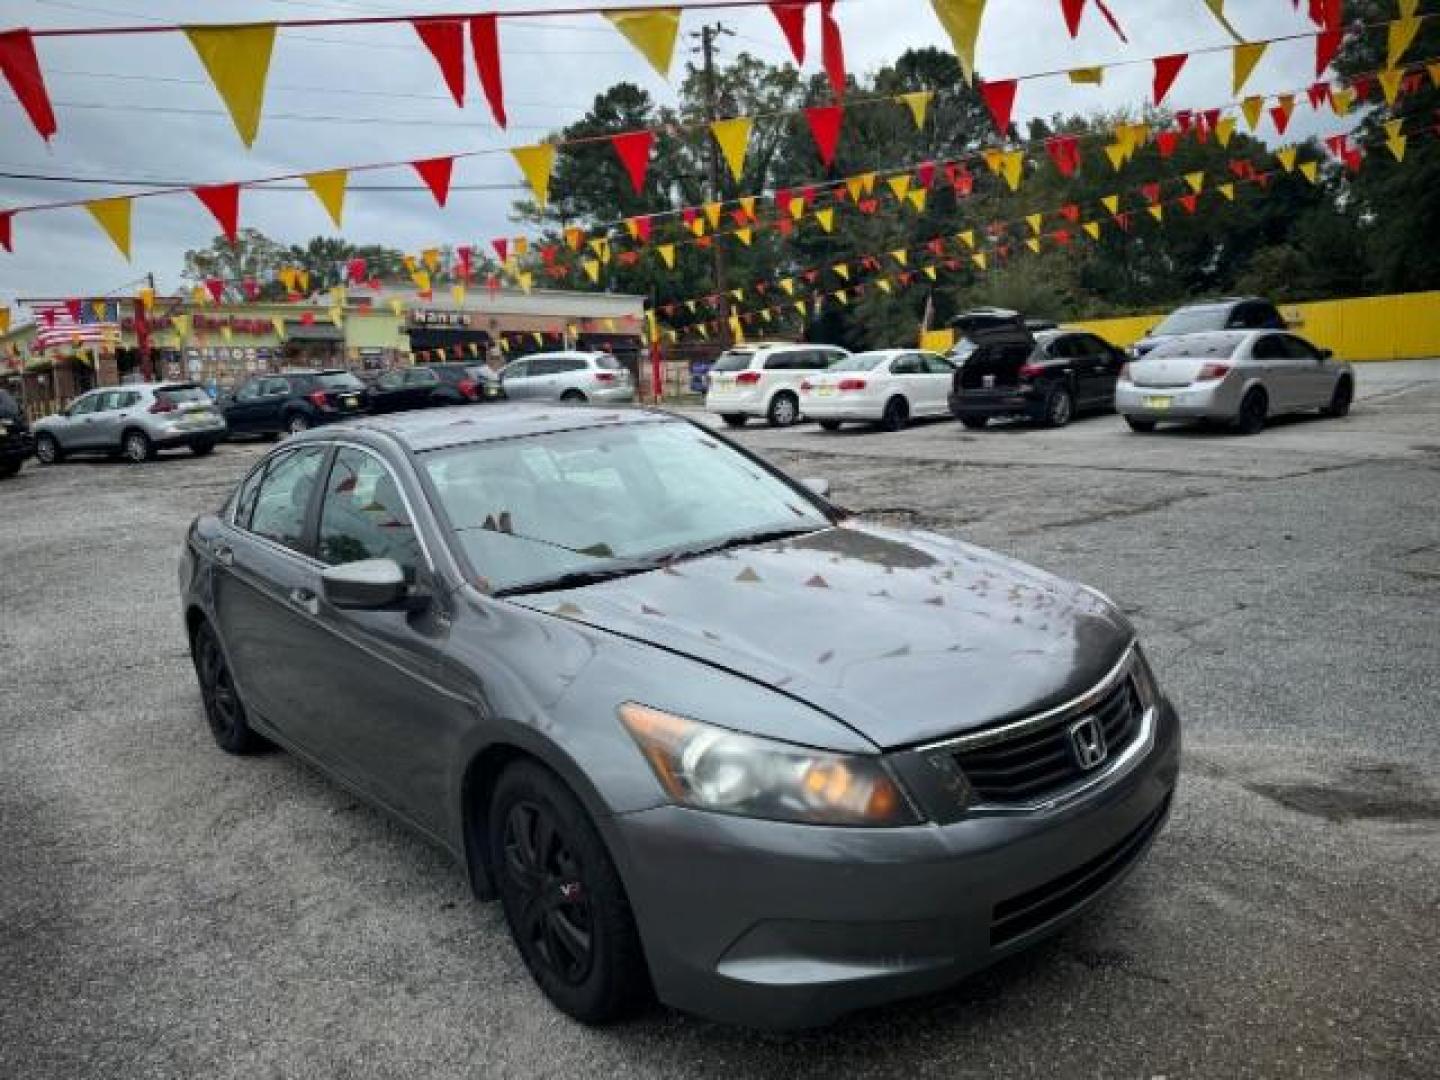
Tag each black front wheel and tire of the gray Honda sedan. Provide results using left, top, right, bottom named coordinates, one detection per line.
left=488, top=762, right=648, bottom=1024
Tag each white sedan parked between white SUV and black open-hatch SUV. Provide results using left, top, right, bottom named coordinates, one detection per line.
left=801, top=348, right=955, bottom=431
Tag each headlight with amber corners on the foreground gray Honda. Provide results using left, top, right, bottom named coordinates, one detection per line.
left=619, top=703, right=919, bottom=825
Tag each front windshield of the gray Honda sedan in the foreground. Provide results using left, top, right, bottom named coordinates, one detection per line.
left=422, top=420, right=829, bottom=592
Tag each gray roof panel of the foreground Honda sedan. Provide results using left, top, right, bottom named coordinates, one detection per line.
left=295, top=402, right=685, bottom=454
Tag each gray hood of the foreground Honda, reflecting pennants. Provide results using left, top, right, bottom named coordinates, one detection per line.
left=513, top=523, right=1133, bottom=749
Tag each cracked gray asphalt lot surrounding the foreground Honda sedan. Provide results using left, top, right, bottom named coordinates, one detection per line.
left=0, top=361, right=1440, bottom=1080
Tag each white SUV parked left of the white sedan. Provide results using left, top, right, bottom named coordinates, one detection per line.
left=706, top=343, right=850, bottom=428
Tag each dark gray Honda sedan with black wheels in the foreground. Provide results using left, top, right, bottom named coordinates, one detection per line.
left=180, top=405, right=1179, bottom=1027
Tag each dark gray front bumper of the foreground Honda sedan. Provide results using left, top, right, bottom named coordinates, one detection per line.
left=606, top=701, right=1181, bottom=1028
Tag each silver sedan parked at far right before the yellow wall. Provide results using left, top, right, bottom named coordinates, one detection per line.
left=1115, top=330, right=1355, bottom=435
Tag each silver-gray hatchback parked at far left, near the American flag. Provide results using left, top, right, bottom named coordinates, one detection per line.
left=35, top=383, right=226, bottom=465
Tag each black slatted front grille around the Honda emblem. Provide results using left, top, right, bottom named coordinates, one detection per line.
left=955, top=675, right=1143, bottom=805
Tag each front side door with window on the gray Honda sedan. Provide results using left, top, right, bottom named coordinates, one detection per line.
left=310, top=446, right=468, bottom=835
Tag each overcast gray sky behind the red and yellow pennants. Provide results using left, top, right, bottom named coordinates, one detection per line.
left=0, top=0, right=1333, bottom=311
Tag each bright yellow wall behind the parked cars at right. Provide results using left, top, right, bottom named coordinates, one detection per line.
left=1066, top=292, right=1440, bottom=360
